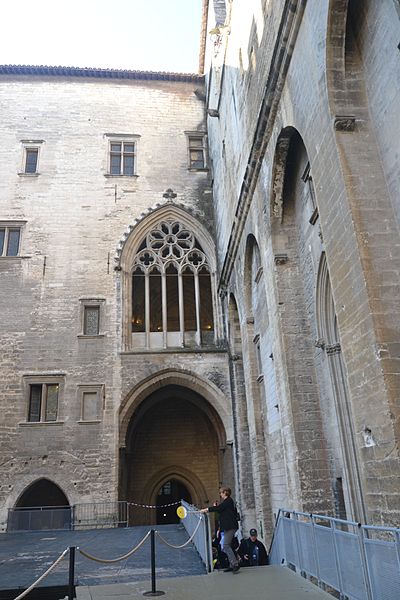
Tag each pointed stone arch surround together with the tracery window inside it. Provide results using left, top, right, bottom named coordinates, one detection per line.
left=119, top=202, right=222, bottom=350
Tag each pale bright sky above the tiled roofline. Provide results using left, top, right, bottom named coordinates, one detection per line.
left=0, top=0, right=202, bottom=73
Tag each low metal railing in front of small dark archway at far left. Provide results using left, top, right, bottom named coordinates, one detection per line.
left=7, top=501, right=128, bottom=531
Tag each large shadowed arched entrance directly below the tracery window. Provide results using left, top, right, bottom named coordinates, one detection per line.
left=120, top=384, right=227, bottom=524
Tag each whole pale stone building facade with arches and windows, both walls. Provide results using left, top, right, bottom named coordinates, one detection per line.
left=0, top=0, right=400, bottom=537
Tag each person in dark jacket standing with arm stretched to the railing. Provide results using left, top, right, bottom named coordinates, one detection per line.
left=201, top=487, right=240, bottom=573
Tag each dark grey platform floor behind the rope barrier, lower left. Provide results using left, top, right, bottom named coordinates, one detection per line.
left=0, top=525, right=205, bottom=590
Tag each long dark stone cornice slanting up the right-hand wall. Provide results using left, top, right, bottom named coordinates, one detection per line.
left=219, top=0, right=307, bottom=295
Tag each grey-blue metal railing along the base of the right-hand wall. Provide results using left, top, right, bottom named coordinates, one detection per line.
left=270, top=509, right=400, bottom=600
